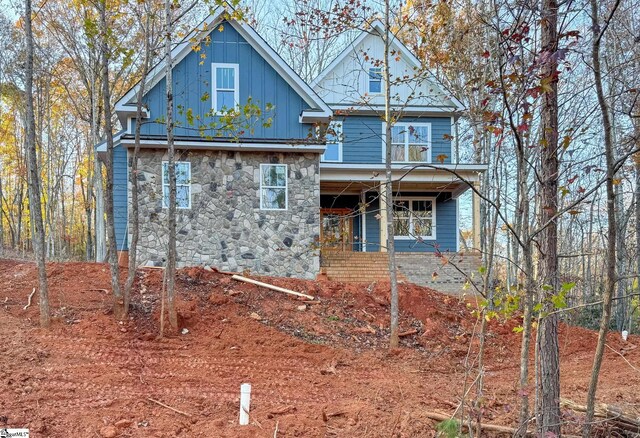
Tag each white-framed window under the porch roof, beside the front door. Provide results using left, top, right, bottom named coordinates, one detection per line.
left=393, top=198, right=436, bottom=239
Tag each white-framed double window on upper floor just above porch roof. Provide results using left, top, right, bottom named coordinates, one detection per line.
left=383, top=123, right=431, bottom=163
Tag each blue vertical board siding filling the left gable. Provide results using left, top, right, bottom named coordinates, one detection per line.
left=136, top=22, right=312, bottom=139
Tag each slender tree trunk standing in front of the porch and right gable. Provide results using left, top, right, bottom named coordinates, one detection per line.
left=380, top=0, right=400, bottom=348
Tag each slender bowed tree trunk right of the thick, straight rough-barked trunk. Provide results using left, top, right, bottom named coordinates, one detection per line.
left=582, top=0, right=617, bottom=438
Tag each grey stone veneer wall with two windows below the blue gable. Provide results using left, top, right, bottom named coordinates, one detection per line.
left=129, top=149, right=320, bottom=278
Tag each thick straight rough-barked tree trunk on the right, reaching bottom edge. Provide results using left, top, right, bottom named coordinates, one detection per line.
left=538, top=0, right=561, bottom=436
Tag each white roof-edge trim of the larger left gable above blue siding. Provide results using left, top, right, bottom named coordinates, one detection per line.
left=115, top=2, right=332, bottom=128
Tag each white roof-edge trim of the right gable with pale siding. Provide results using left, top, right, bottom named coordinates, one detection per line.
left=311, top=20, right=464, bottom=111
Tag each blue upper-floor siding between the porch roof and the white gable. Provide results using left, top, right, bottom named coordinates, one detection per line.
left=342, top=116, right=452, bottom=163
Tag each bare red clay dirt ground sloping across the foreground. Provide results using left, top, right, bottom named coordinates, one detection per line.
left=0, top=260, right=640, bottom=437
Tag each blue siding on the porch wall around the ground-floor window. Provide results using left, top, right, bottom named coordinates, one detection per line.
left=366, top=193, right=458, bottom=252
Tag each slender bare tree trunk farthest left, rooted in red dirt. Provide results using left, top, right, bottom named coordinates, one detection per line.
left=24, top=0, right=51, bottom=327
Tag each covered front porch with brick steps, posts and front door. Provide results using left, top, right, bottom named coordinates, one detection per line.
left=320, top=164, right=481, bottom=293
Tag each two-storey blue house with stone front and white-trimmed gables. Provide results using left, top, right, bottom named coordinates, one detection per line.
left=98, top=6, right=483, bottom=290
